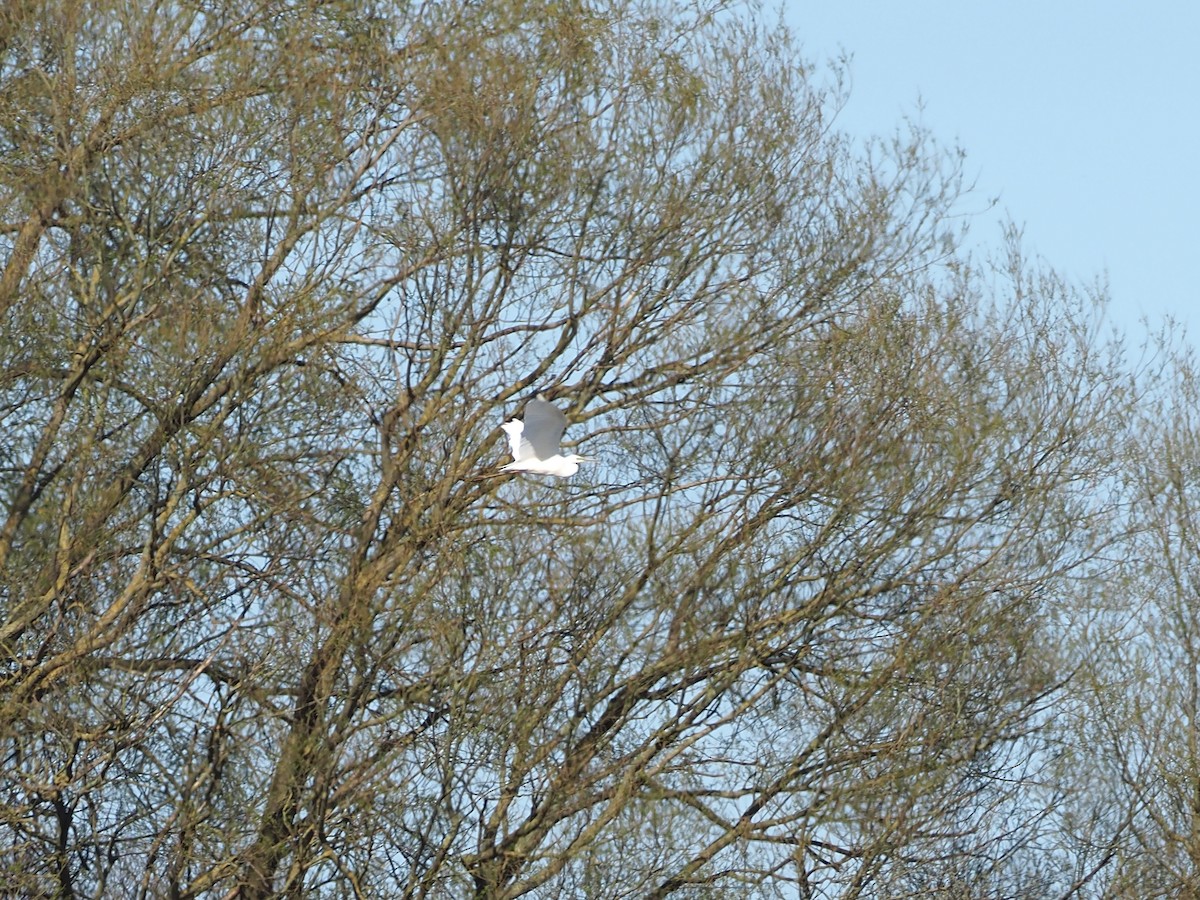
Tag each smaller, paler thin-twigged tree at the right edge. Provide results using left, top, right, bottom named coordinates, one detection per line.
left=1051, top=332, right=1200, bottom=898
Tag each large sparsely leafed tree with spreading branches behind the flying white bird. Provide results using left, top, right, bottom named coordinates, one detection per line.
left=0, top=0, right=1124, bottom=898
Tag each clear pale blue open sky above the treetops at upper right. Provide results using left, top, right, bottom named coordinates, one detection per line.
left=781, top=0, right=1200, bottom=344
